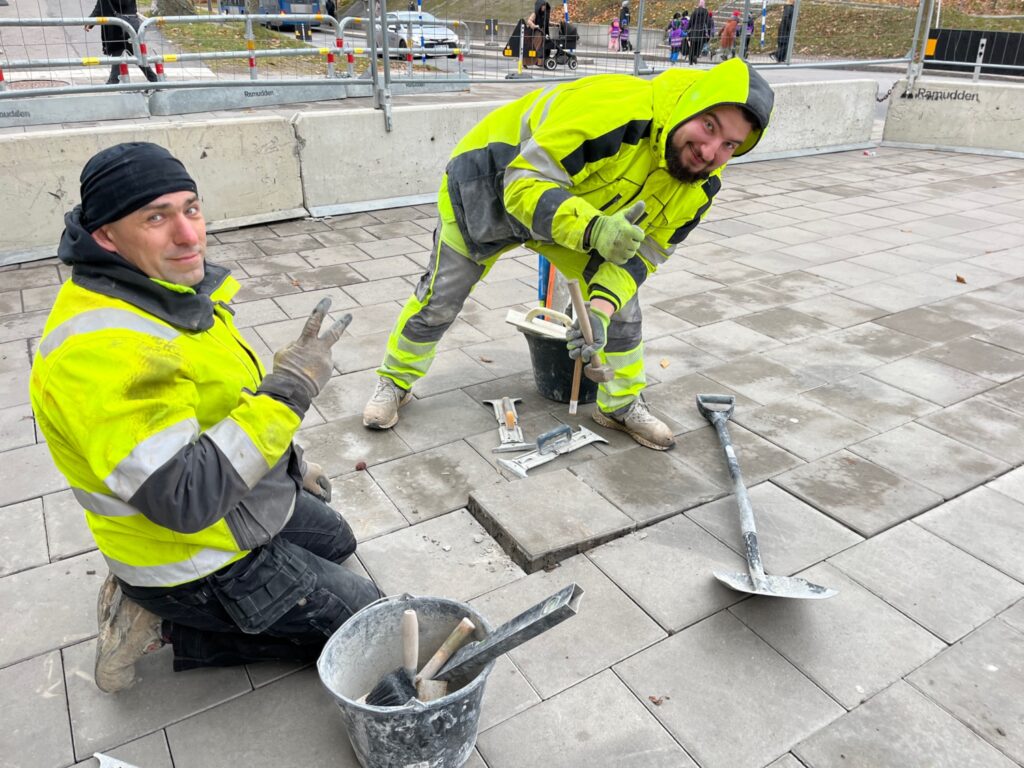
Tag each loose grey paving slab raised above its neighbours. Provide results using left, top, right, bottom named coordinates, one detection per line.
left=469, top=470, right=636, bottom=572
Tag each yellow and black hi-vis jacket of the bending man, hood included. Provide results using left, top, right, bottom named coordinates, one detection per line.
left=441, top=58, right=774, bottom=309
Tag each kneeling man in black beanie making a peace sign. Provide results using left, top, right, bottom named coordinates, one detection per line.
left=31, top=143, right=379, bottom=692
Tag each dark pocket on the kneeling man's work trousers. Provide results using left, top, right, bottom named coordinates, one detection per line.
left=210, top=541, right=316, bottom=635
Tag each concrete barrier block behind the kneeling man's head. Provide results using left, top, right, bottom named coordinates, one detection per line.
left=0, top=116, right=306, bottom=263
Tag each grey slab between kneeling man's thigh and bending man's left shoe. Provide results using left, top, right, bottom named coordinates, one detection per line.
left=295, top=416, right=410, bottom=477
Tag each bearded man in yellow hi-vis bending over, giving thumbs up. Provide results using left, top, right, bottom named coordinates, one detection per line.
left=362, top=59, right=774, bottom=451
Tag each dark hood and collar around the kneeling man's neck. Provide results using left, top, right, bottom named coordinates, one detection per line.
left=57, top=206, right=238, bottom=331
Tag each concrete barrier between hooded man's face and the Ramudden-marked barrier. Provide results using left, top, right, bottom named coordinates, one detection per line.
left=741, top=80, right=878, bottom=160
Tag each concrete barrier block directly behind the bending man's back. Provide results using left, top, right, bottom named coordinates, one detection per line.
left=295, top=101, right=505, bottom=216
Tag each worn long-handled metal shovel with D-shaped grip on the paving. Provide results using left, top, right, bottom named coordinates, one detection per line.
left=697, top=394, right=839, bottom=600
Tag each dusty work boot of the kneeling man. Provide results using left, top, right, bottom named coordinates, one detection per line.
left=94, top=573, right=164, bottom=693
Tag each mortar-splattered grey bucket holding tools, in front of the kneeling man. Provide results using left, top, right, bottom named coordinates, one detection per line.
left=316, top=595, right=495, bottom=768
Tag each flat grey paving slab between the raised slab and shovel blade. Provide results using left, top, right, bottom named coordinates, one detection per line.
left=588, top=516, right=745, bottom=632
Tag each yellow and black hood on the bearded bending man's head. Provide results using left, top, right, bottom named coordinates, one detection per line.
left=651, top=58, right=775, bottom=158
